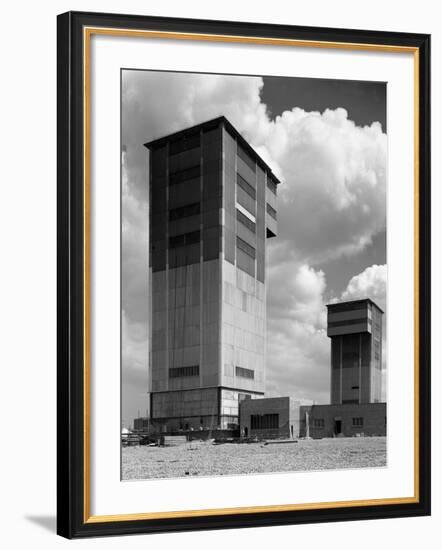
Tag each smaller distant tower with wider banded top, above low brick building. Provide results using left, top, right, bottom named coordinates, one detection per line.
left=327, top=299, right=384, bottom=405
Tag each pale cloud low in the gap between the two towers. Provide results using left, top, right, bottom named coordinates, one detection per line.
left=266, top=261, right=330, bottom=403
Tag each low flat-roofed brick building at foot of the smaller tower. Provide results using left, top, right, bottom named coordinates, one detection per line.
left=299, top=403, right=387, bottom=439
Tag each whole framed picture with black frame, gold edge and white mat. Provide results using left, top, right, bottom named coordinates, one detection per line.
left=57, top=12, right=430, bottom=538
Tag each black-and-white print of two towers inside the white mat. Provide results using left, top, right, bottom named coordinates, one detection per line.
left=120, top=68, right=389, bottom=480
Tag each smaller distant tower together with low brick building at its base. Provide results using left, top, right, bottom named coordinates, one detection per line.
left=299, top=298, right=387, bottom=438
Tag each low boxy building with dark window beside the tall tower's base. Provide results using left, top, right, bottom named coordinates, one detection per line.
left=239, top=397, right=299, bottom=439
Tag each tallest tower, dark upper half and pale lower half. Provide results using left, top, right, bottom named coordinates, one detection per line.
left=145, top=117, right=279, bottom=430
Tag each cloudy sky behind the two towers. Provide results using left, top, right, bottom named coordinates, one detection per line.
left=122, top=70, right=387, bottom=427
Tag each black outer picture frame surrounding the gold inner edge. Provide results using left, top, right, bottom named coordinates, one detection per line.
left=57, top=12, right=431, bottom=538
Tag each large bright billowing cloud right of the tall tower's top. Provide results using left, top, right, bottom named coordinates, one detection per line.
left=267, top=108, right=387, bottom=263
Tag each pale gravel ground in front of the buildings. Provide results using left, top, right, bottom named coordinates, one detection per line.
left=122, top=437, right=387, bottom=480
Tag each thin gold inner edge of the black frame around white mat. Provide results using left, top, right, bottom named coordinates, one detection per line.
left=83, top=26, right=420, bottom=523
